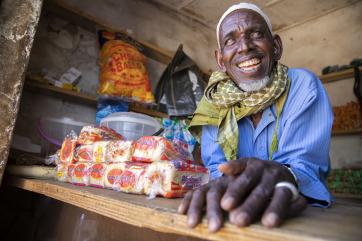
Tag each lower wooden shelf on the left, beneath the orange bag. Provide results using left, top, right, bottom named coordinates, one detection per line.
left=24, top=77, right=169, bottom=118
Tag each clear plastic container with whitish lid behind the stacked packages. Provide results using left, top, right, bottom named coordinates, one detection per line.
left=101, top=112, right=162, bottom=140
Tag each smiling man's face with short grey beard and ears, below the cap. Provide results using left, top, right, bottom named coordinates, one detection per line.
left=216, top=9, right=282, bottom=85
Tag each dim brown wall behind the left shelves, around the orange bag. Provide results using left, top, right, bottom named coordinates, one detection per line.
left=15, top=9, right=166, bottom=149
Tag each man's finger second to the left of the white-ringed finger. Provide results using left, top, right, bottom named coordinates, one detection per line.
left=221, top=162, right=263, bottom=211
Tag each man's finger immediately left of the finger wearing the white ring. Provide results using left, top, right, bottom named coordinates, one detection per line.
left=230, top=173, right=276, bottom=227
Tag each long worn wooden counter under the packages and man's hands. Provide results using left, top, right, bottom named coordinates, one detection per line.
left=9, top=177, right=362, bottom=241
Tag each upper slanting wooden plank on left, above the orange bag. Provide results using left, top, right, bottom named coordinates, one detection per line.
left=45, top=0, right=173, bottom=64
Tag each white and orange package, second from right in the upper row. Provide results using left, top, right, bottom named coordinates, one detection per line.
left=106, top=141, right=133, bottom=162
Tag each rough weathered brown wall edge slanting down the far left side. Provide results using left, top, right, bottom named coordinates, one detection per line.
left=0, top=0, right=42, bottom=182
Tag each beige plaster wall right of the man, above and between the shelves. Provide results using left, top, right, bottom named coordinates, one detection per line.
left=279, top=1, right=362, bottom=168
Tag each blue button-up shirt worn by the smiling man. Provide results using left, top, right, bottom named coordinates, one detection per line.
left=201, top=69, right=333, bottom=204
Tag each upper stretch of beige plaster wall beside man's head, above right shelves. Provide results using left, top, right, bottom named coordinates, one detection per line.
left=279, top=1, right=362, bottom=74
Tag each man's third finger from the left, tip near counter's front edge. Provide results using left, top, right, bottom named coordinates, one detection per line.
left=206, top=185, right=225, bottom=232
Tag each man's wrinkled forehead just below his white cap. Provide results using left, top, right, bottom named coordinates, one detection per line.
left=218, top=9, right=269, bottom=39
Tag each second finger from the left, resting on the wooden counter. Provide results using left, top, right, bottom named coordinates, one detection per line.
left=187, top=187, right=207, bottom=228
